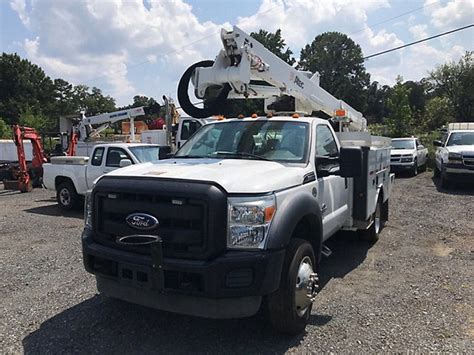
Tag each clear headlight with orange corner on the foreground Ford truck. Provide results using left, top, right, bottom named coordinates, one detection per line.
left=227, top=195, right=276, bottom=249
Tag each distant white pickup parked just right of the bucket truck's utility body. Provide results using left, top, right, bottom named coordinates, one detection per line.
left=390, top=137, right=428, bottom=176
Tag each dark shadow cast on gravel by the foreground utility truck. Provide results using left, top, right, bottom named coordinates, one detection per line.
left=23, top=233, right=370, bottom=354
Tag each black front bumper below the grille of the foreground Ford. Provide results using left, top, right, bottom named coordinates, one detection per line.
left=82, top=228, right=284, bottom=318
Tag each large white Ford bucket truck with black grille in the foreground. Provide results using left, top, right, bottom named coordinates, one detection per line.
left=82, top=27, right=393, bottom=334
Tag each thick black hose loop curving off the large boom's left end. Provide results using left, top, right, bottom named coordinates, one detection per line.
left=178, top=60, right=231, bottom=118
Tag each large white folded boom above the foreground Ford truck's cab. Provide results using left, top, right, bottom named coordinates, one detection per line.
left=192, top=26, right=367, bottom=131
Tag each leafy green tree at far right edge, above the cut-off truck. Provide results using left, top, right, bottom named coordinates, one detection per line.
left=428, top=52, right=474, bottom=122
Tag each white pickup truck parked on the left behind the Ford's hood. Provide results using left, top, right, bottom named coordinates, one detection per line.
left=43, top=143, right=169, bottom=210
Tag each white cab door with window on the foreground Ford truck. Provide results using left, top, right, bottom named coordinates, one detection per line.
left=316, top=124, right=349, bottom=240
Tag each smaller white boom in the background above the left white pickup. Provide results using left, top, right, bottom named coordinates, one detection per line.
left=77, top=106, right=145, bottom=142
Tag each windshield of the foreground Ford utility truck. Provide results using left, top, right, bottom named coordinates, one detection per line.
left=175, top=120, right=309, bottom=163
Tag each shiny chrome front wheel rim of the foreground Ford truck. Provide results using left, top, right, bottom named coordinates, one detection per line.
left=295, top=256, right=318, bottom=317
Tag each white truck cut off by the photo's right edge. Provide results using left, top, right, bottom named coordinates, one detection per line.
left=433, top=122, right=474, bottom=188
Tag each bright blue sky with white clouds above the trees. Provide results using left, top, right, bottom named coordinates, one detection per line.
left=0, top=0, right=474, bottom=105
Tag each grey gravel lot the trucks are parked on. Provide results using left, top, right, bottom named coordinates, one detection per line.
left=0, top=173, right=474, bottom=353
